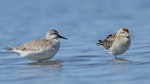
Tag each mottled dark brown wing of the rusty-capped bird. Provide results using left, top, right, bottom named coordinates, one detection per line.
left=97, top=33, right=116, bottom=50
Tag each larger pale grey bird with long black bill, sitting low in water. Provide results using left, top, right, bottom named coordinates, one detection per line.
left=8, top=29, right=68, bottom=61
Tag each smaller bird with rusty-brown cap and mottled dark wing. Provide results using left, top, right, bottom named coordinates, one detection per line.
left=97, top=28, right=131, bottom=59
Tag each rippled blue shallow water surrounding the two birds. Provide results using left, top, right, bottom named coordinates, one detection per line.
left=0, top=0, right=150, bottom=84
